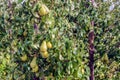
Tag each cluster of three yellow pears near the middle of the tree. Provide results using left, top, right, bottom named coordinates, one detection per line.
left=40, top=41, right=52, bottom=58
